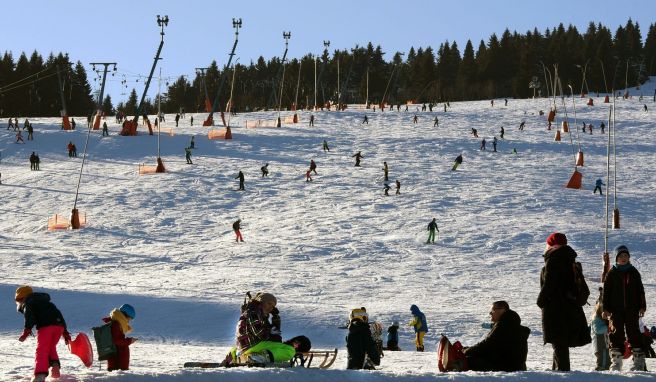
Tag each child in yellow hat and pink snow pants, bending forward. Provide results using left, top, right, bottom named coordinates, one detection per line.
left=14, top=285, right=71, bottom=382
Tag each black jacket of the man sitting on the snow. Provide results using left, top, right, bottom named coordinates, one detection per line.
left=465, top=310, right=531, bottom=371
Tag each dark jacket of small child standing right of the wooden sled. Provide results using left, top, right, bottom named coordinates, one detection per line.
left=346, top=320, right=380, bottom=370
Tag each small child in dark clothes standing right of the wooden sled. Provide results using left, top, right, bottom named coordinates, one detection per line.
left=346, top=307, right=380, bottom=370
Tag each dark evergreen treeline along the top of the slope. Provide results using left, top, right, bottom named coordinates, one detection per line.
left=0, top=19, right=656, bottom=116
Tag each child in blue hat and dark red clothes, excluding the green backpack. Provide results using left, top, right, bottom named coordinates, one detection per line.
left=102, top=304, right=137, bottom=371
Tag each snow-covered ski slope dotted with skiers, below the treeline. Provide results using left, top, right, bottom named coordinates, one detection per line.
left=0, top=79, right=656, bottom=382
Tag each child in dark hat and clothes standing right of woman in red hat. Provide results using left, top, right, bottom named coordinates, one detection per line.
left=602, top=245, right=647, bottom=371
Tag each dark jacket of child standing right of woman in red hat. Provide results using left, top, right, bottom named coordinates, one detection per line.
left=603, top=264, right=647, bottom=313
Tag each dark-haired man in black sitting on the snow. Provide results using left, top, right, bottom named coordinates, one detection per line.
left=464, top=301, right=531, bottom=371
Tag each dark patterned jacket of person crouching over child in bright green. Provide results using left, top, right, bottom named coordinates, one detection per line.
left=237, top=300, right=282, bottom=353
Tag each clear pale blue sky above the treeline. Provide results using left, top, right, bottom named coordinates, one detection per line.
left=0, top=0, right=656, bottom=103
